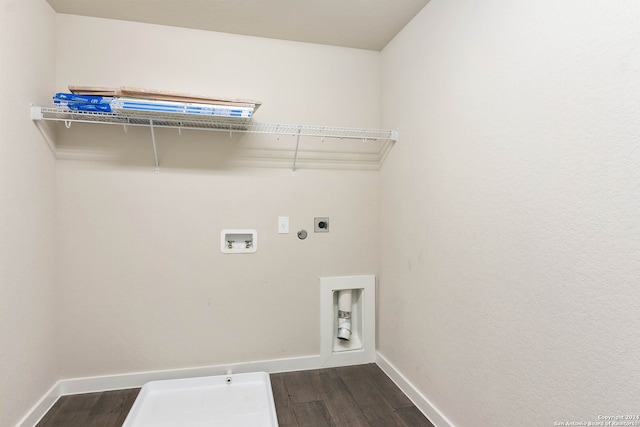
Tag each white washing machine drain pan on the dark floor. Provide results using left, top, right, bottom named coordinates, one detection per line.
left=122, top=372, right=278, bottom=427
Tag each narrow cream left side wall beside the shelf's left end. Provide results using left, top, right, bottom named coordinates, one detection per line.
left=0, top=0, right=58, bottom=426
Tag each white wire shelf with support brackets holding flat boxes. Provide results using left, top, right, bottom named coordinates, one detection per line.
left=31, top=106, right=398, bottom=172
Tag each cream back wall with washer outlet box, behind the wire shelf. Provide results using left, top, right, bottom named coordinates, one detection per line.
left=57, top=15, right=380, bottom=378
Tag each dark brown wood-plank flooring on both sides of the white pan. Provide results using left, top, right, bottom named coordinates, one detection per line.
left=36, top=364, right=433, bottom=427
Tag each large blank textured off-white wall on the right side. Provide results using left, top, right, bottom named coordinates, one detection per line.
left=378, top=0, right=640, bottom=427
